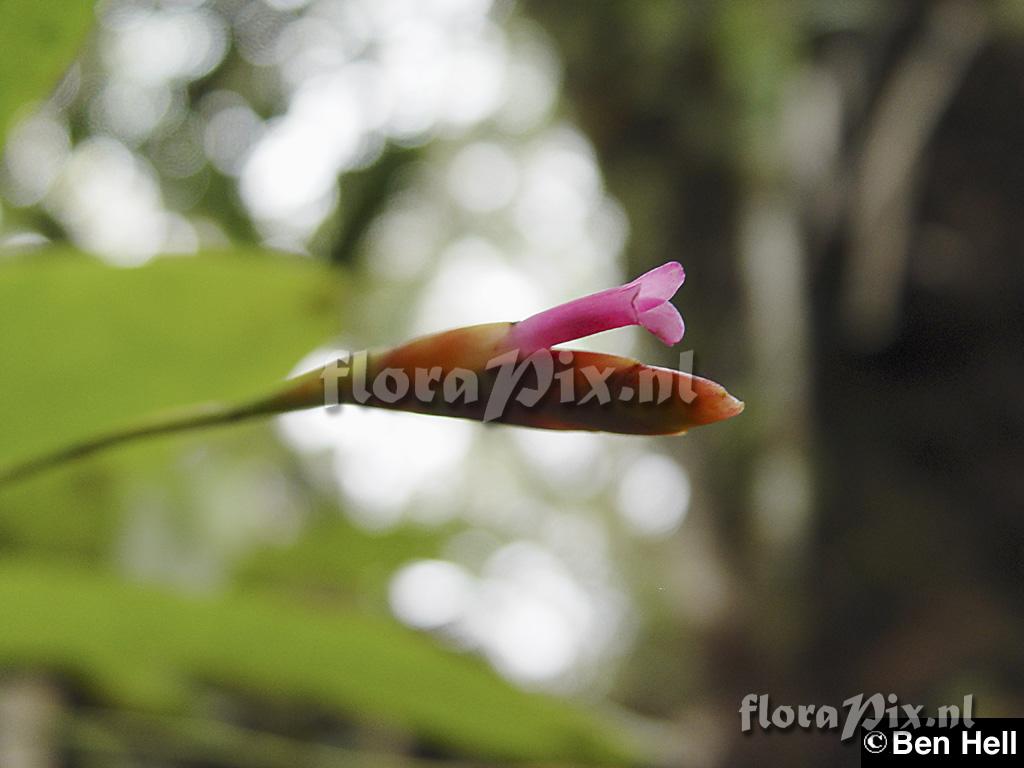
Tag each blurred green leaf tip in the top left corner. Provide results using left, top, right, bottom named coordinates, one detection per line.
left=0, top=0, right=93, bottom=145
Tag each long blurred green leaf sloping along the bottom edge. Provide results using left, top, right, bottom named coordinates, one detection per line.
left=0, top=560, right=627, bottom=765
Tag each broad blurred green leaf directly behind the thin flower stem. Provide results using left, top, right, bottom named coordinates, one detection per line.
left=0, top=250, right=342, bottom=558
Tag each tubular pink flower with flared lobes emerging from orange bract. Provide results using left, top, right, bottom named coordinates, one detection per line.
left=504, top=261, right=686, bottom=355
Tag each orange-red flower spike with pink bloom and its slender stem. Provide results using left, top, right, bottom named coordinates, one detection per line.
left=0, top=261, right=743, bottom=484
